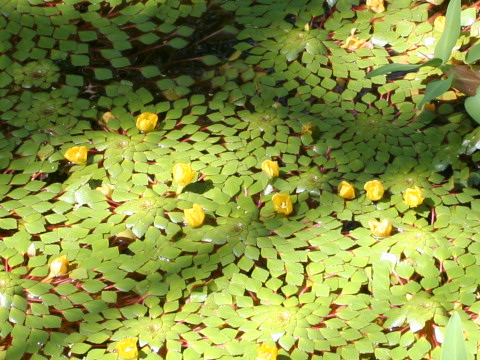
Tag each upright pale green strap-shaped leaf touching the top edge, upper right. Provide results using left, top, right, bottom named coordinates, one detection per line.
left=434, top=0, right=462, bottom=63
